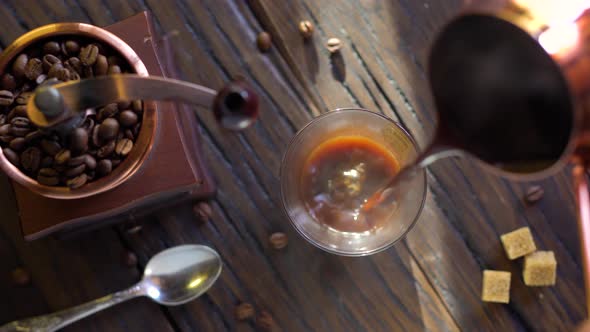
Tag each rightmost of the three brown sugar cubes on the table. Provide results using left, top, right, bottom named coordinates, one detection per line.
left=522, top=251, right=557, bottom=286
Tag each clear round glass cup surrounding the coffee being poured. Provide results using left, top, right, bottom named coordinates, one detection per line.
left=280, top=109, right=426, bottom=256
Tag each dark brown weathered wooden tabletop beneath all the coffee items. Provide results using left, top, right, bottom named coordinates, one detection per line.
left=0, top=0, right=585, bottom=331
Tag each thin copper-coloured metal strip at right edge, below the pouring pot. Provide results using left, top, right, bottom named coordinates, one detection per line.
left=572, top=161, right=590, bottom=317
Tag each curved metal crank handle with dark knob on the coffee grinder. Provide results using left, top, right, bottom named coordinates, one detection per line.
left=27, top=74, right=258, bottom=130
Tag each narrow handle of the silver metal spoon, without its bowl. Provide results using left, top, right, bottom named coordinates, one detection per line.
left=0, top=284, right=144, bottom=332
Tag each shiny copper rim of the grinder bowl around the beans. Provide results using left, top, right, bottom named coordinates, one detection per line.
left=0, top=23, right=158, bottom=199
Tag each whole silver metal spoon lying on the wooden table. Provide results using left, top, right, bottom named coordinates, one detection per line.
left=0, top=245, right=222, bottom=332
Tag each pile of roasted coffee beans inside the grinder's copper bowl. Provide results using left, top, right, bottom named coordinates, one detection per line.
left=0, top=38, right=143, bottom=189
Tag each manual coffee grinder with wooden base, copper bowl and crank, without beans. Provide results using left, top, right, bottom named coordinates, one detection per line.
left=0, top=12, right=258, bottom=240
